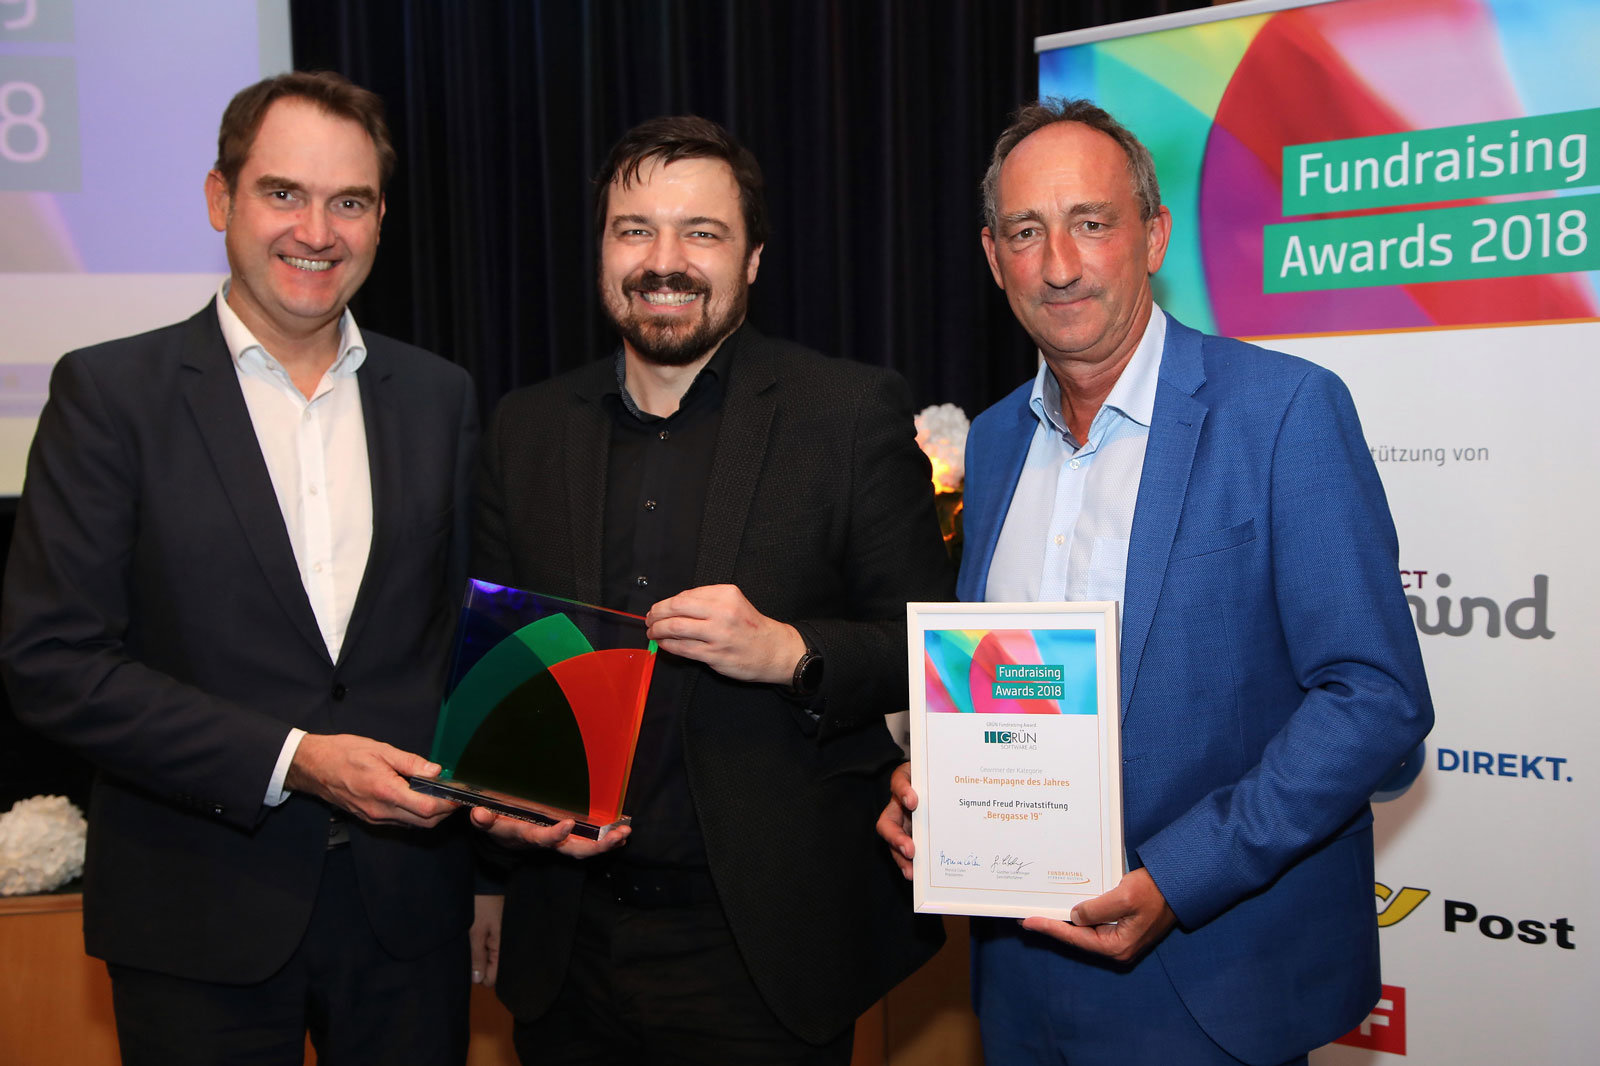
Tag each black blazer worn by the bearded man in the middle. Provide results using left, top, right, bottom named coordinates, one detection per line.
left=474, top=327, right=954, bottom=1042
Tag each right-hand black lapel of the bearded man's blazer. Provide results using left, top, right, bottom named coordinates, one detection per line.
left=694, top=327, right=778, bottom=586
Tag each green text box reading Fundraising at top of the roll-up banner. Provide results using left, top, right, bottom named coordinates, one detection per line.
left=1283, top=107, right=1600, bottom=216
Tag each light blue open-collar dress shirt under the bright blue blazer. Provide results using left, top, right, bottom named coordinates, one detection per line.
left=986, top=306, right=1166, bottom=605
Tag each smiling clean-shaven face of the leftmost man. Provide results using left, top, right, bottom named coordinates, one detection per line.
left=206, top=96, right=384, bottom=344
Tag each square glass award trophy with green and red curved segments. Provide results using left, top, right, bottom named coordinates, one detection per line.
left=410, top=579, right=656, bottom=840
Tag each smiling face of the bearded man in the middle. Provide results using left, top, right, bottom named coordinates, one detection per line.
left=600, top=158, right=762, bottom=367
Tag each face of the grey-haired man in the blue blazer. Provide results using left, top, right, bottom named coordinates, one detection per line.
left=982, top=122, right=1171, bottom=365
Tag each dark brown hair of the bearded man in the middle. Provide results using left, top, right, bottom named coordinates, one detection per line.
left=595, top=115, right=766, bottom=253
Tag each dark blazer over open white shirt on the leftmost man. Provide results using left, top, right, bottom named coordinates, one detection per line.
left=0, top=304, right=477, bottom=983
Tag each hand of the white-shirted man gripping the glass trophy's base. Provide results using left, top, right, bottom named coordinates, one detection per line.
left=283, top=733, right=456, bottom=828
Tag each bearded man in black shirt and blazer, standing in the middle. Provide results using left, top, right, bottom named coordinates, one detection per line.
left=474, top=118, right=952, bottom=1063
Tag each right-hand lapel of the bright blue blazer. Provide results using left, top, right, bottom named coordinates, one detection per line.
left=1122, top=315, right=1206, bottom=717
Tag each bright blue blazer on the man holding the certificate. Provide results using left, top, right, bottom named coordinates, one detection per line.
left=958, top=319, right=1434, bottom=1063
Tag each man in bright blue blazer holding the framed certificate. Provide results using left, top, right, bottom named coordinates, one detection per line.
left=880, top=101, right=1432, bottom=1066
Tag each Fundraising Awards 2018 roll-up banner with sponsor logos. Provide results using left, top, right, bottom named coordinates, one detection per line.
left=1037, top=0, right=1600, bottom=1066
